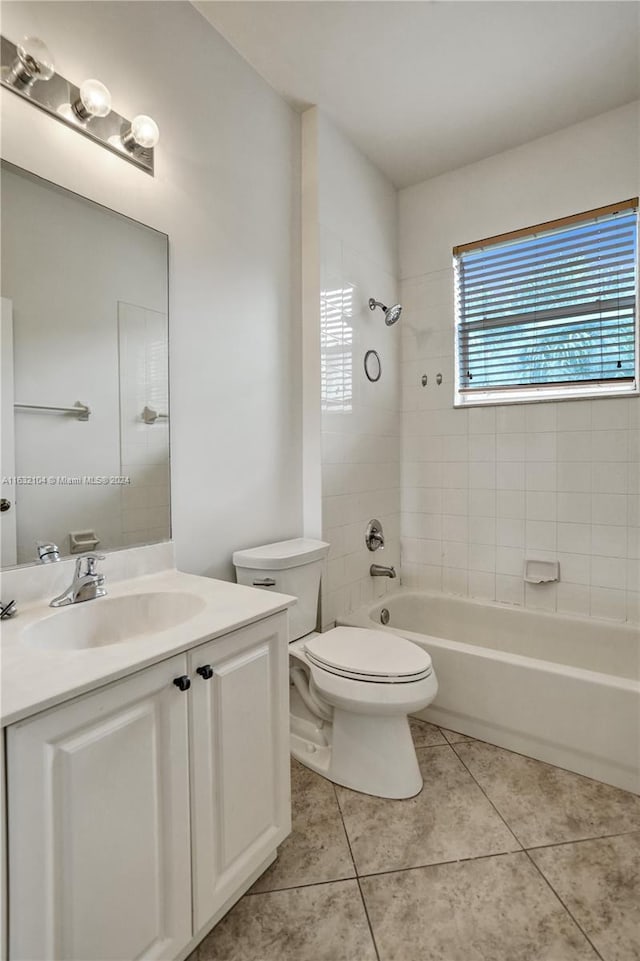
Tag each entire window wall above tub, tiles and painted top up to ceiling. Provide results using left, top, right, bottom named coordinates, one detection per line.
left=399, top=104, right=640, bottom=620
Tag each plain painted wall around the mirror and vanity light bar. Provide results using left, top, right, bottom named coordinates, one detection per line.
left=1, top=0, right=302, bottom=577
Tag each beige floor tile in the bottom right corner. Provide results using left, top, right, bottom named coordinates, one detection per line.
left=531, top=833, right=640, bottom=961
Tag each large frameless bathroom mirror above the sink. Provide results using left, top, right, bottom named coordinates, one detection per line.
left=0, top=162, right=170, bottom=567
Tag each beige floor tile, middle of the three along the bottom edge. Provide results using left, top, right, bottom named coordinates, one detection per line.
left=361, top=853, right=597, bottom=961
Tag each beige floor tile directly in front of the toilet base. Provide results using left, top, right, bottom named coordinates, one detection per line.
left=337, top=746, right=520, bottom=874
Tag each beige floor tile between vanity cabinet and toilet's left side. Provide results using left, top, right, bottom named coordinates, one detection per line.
left=251, top=761, right=355, bottom=891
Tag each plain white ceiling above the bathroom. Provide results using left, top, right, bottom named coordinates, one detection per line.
left=195, top=0, right=640, bottom=187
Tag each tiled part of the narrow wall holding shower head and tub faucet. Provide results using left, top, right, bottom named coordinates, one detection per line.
left=321, top=230, right=401, bottom=626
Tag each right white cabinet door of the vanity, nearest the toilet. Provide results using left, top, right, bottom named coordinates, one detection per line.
left=189, top=614, right=291, bottom=932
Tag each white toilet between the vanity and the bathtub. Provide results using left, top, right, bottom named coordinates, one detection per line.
left=233, top=538, right=438, bottom=798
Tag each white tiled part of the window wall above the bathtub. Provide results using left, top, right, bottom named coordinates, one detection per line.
left=401, top=270, right=640, bottom=622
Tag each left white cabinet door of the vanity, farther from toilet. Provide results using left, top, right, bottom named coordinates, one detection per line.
left=7, top=655, right=191, bottom=961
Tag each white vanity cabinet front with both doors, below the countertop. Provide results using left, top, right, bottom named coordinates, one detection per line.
left=7, top=613, right=290, bottom=961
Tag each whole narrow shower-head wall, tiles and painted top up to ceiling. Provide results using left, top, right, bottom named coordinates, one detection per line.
left=303, top=109, right=402, bottom=626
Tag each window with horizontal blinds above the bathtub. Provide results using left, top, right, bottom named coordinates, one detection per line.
left=453, top=198, right=638, bottom=406
